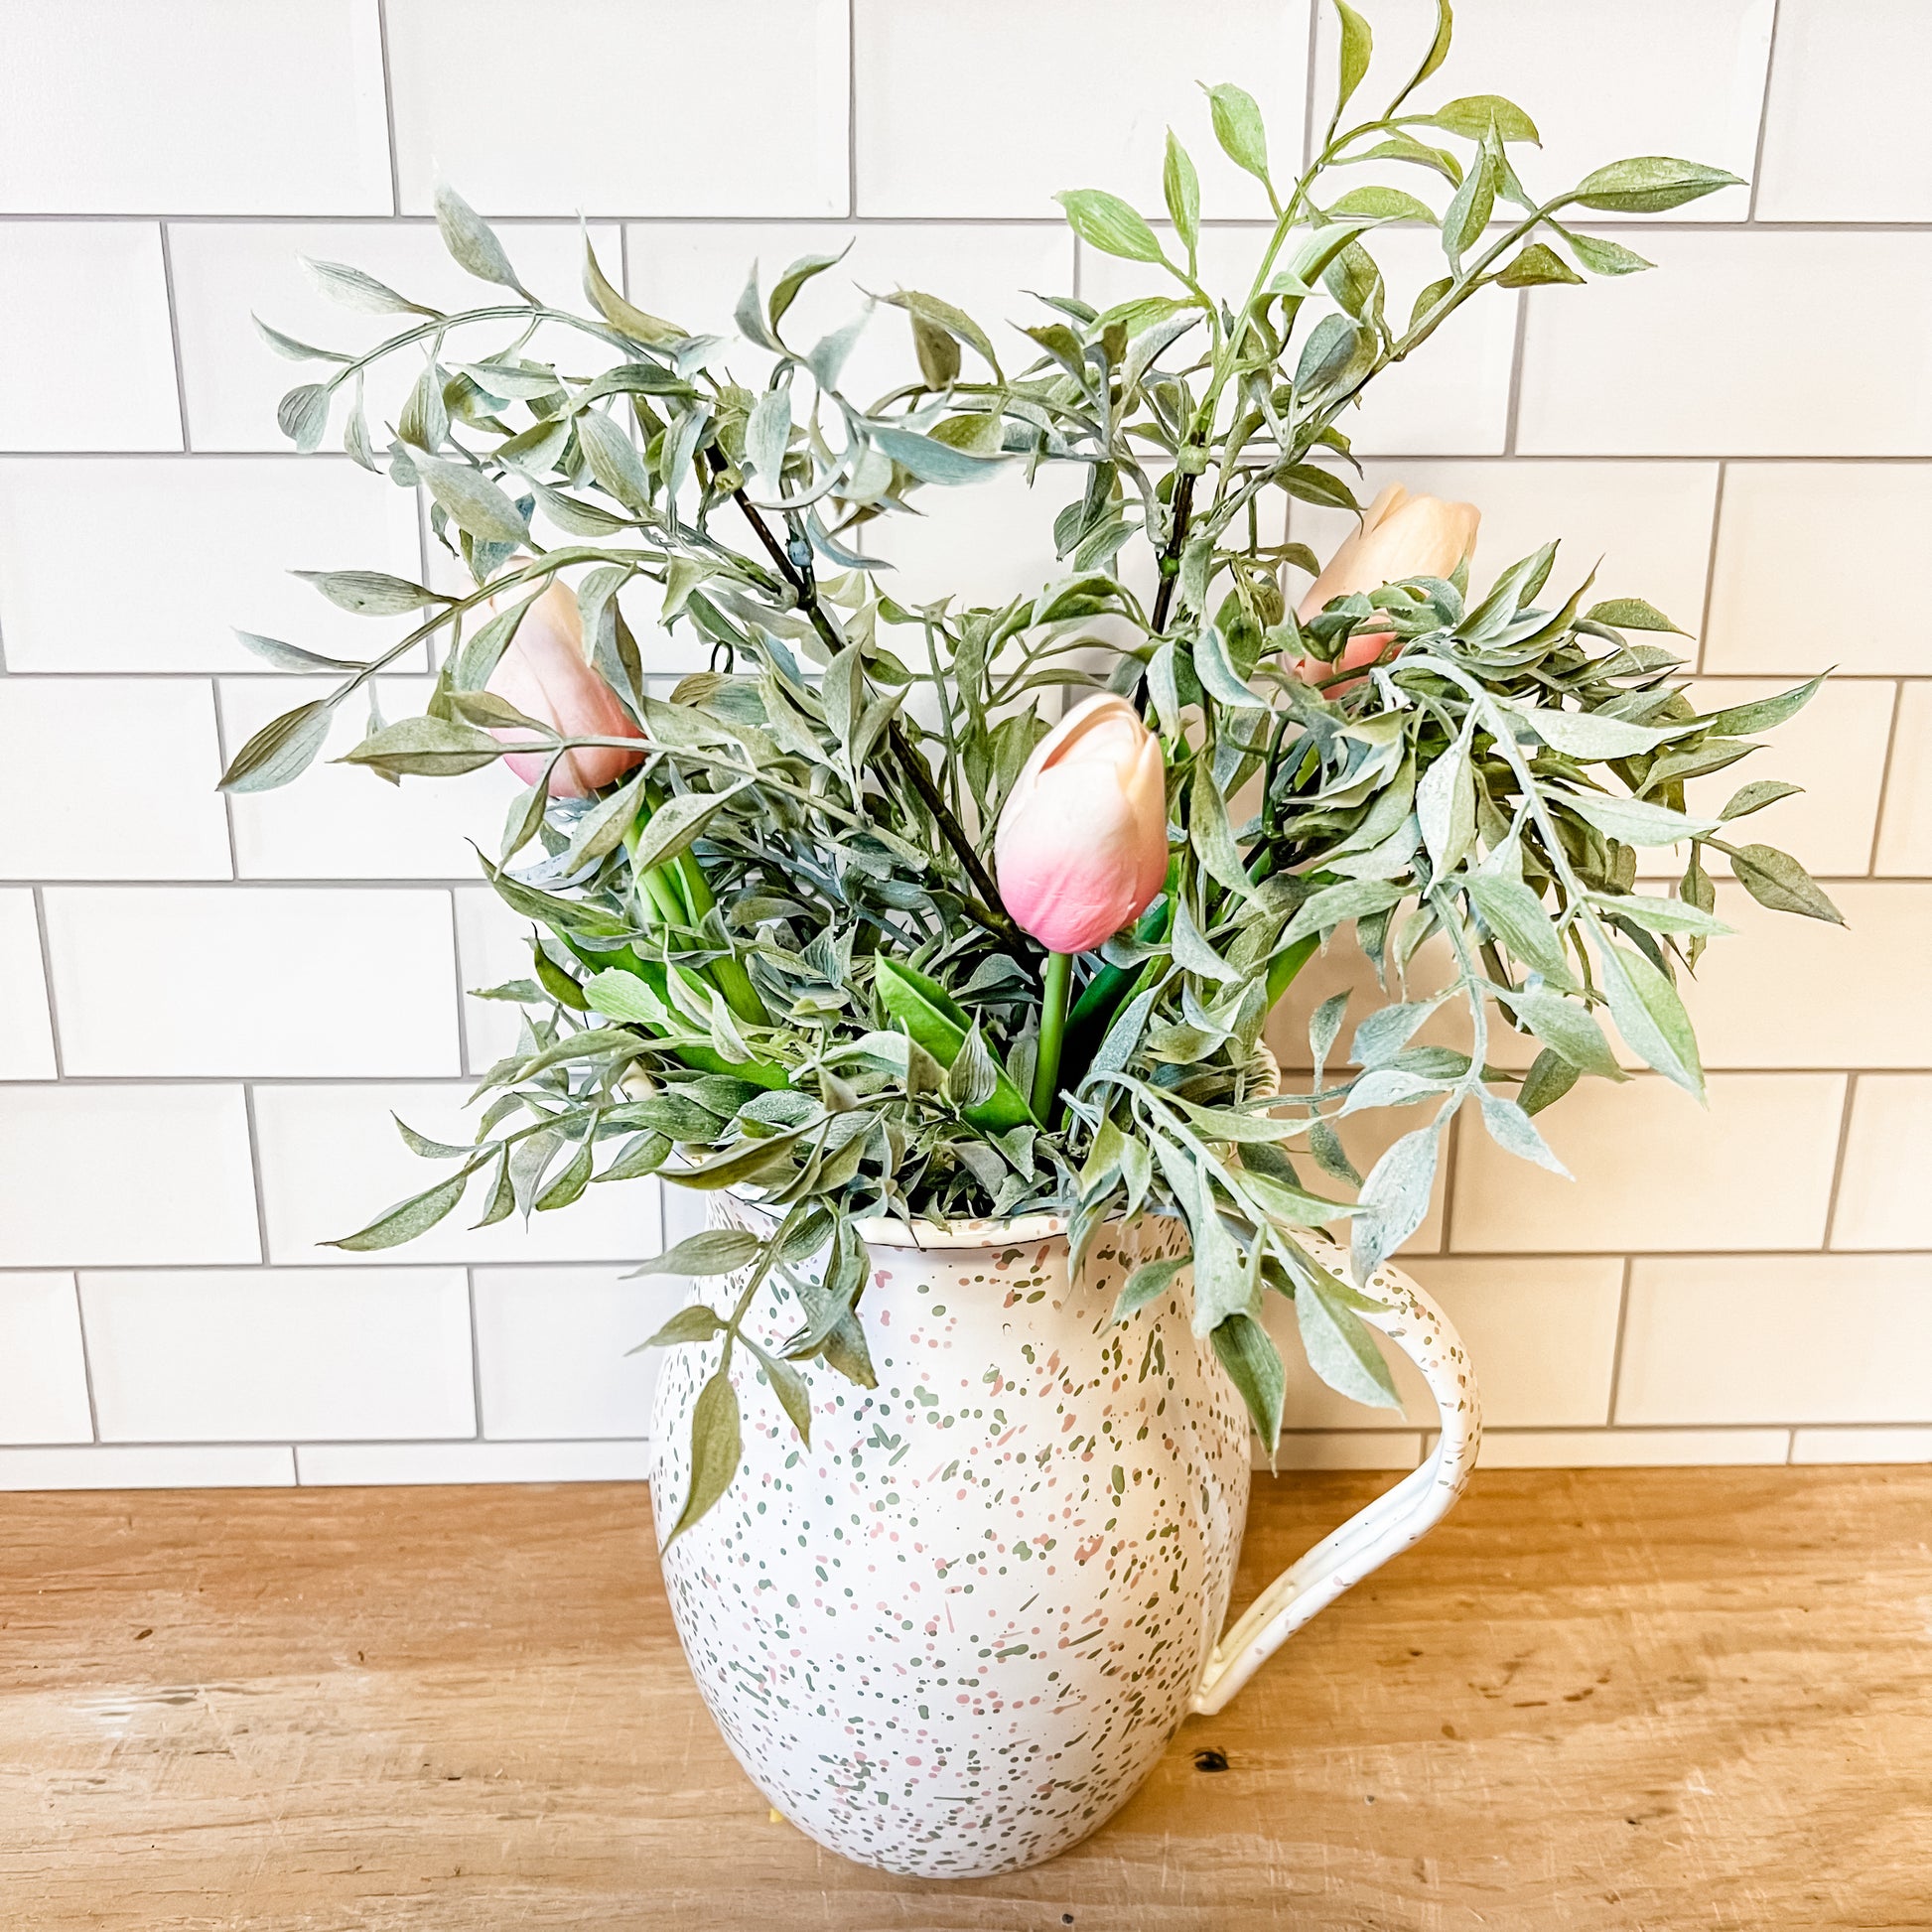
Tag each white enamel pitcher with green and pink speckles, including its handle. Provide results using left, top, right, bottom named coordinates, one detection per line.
left=651, top=1196, right=1478, bottom=1878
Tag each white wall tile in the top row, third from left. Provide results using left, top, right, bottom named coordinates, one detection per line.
left=852, top=0, right=1308, bottom=218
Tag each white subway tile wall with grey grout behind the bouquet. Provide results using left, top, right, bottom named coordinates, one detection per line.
left=0, top=0, right=1932, bottom=1487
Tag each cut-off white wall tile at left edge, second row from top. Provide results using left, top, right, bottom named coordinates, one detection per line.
left=0, top=223, right=182, bottom=450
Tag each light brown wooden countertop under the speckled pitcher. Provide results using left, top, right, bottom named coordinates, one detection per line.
left=0, top=1468, right=1932, bottom=1932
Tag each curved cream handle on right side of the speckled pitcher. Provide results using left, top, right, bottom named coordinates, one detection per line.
left=1188, top=1268, right=1482, bottom=1716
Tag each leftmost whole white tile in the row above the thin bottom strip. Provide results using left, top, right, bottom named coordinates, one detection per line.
left=81, top=1268, right=476, bottom=1442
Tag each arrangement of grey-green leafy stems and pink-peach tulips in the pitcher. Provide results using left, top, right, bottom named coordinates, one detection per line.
left=222, top=4, right=1838, bottom=1528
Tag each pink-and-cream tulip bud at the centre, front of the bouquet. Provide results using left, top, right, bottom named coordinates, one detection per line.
left=993, top=698, right=1167, bottom=952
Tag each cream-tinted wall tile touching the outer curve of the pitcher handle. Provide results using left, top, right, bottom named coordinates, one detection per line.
left=1407, top=1256, right=1623, bottom=1428
